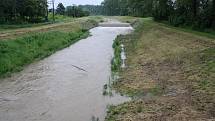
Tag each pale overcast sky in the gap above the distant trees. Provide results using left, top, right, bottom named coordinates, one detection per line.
left=51, top=0, right=103, bottom=6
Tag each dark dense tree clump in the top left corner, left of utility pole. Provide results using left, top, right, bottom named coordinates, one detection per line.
left=0, top=0, right=48, bottom=23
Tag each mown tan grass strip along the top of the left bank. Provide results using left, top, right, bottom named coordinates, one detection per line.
left=0, top=16, right=102, bottom=40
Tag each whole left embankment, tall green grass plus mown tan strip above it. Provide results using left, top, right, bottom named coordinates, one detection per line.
left=0, top=17, right=102, bottom=78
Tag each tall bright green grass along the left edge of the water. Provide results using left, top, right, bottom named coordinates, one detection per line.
left=0, top=30, right=86, bottom=77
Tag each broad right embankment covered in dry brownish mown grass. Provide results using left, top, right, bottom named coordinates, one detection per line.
left=106, top=18, right=215, bottom=121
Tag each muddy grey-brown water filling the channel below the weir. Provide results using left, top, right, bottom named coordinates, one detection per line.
left=0, top=23, right=132, bottom=121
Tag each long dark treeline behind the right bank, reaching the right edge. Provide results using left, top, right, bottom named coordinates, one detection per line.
left=82, top=0, right=215, bottom=30
